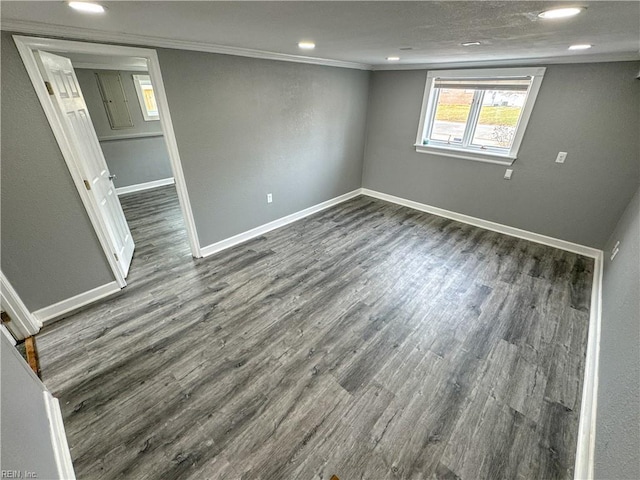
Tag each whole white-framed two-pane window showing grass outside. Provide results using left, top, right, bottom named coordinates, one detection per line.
left=415, top=68, right=545, bottom=165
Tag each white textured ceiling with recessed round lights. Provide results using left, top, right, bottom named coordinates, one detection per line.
left=1, top=0, right=640, bottom=68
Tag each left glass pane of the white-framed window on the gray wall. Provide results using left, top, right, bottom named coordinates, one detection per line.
left=429, top=88, right=475, bottom=143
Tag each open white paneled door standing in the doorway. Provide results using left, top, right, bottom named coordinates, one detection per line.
left=35, top=51, right=135, bottom=278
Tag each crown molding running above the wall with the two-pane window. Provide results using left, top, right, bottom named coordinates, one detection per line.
left=371, top=52, right=640, bottom=71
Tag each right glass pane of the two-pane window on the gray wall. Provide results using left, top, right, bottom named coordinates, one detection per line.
left=471, top=90, right=527, bottom=149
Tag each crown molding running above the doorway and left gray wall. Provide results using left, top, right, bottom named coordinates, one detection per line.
left=0, top=19, right=372, bottom=70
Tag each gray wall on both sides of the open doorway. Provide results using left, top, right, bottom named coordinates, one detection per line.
left=1, top=32, right=369, bottom=311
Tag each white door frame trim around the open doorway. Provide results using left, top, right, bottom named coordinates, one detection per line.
left=13, top=35, right=202, bottom=288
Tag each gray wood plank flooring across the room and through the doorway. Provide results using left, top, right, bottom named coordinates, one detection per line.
left=38, top=187, right=593, bottom=480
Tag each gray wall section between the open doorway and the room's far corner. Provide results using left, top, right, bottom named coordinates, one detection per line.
left=158, top=50, right=369, bottom=246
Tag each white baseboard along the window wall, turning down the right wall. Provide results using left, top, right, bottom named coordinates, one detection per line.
left=362, top=188, right=604, bottom=480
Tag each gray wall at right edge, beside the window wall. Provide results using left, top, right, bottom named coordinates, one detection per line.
left=595, top=190, right=640, bottom=479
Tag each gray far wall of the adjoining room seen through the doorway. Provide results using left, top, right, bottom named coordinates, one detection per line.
left=76, top=68, right=173, bottom=187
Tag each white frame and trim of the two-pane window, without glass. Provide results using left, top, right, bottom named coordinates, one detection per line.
left=414, top=67, right=546, bottom=165
